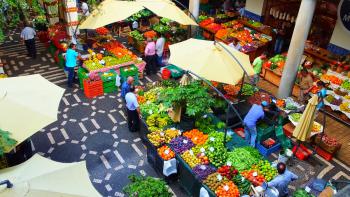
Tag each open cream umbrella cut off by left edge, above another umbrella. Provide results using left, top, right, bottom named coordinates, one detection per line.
left=0, top=74, right=65, bottom=151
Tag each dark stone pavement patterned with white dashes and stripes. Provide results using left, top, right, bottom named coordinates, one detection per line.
left=0, top=30, right=350, bottom=196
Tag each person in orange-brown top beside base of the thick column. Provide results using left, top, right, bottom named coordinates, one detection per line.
left=299, top=69, right=314, bottom=104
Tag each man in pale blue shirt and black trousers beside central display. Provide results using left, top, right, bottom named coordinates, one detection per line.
left=125, top=86, right=140, bottom=132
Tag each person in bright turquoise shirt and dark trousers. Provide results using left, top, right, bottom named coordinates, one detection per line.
left=66, top=43, right=79, bottom=88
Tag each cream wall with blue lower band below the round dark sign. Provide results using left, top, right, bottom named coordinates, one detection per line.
left=328, top=20, right=350, bottom=55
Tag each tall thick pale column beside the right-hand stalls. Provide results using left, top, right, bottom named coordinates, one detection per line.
left=278, top=0, right=317, bottom=98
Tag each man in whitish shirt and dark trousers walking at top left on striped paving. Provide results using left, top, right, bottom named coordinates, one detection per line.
left=21, top=23, right=36, bottom=59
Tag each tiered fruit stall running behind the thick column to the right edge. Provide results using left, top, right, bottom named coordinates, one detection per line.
left=261, top=43, right=350, bottom=125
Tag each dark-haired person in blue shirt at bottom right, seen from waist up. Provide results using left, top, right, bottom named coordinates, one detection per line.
left=267, top=163, right=298, bottom=197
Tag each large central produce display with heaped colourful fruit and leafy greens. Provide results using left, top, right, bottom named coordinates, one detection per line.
left=138, top=81, right=284, bottom=197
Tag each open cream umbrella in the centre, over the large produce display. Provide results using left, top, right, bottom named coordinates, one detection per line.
left=169, top=38, right=254, bottom=85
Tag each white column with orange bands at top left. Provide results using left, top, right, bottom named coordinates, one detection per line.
left=64, top=0, right=79, bottom=36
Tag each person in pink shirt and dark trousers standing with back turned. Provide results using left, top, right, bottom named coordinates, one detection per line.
left=145, top=38, right=157, bottom=75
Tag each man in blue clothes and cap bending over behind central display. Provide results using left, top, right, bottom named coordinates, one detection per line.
left=243, top=101, right=269, bottom=147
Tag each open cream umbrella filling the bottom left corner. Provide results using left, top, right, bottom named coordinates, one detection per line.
left=0, top=154, right=101, bottom=197
